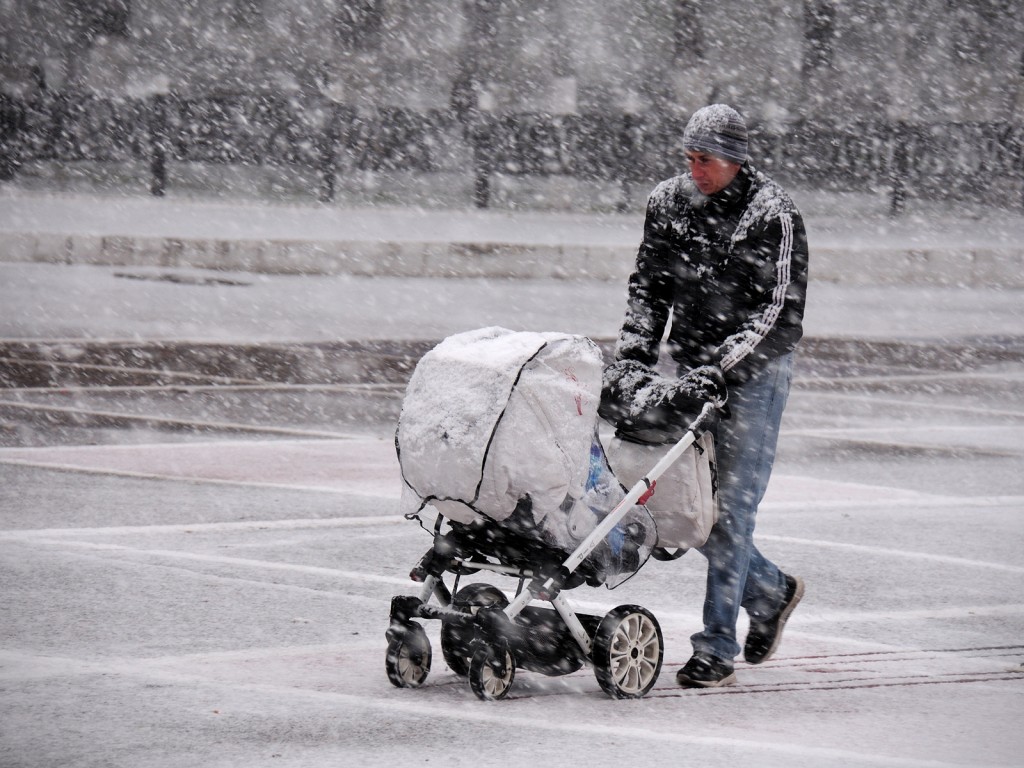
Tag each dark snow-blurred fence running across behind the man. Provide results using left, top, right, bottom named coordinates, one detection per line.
left=0, top=93, right=1024, bottom=214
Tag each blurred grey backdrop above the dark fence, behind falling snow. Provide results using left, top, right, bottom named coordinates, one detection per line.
left=0, top=0, right=1024, bottom=210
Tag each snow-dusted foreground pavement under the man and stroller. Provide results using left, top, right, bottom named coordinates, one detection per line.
left=0, top=423, right=1024, bottom=768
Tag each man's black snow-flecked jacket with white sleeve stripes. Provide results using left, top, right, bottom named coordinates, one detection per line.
left=615, top=163, right=808, bottom=385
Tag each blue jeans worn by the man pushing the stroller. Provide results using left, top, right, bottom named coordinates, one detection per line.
left=690, top=353, right=793, bottom=660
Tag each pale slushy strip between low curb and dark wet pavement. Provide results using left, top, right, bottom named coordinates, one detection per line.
left=0, top=262, right=1024, bottom=344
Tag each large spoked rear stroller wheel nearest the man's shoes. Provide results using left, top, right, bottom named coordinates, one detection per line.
left=592, top=605, right=665, bottom=698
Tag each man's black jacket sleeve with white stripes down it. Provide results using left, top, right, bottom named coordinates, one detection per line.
left=714, top=211, right=807, bottom=381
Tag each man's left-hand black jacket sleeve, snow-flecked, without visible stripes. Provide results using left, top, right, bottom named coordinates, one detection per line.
left=615, top=190, right=673, bottom=366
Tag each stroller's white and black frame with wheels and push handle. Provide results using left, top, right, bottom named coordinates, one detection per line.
left=385, top=402, right=716, bottom=700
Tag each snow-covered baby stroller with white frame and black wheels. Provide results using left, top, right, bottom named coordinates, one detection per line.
left=385, top=328, right=717, bottom=699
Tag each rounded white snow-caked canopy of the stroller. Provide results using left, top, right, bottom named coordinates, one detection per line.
left=395, top=328, right=602, bottom=522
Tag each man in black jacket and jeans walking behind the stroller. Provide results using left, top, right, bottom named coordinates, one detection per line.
left=602, top=104, right=808, bottom=688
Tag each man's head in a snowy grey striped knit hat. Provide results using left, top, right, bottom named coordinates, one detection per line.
left=683, top=104, right=746, bottom=195
